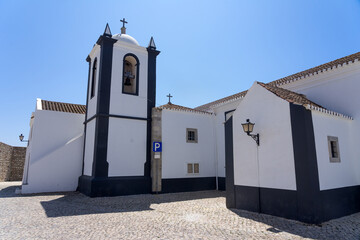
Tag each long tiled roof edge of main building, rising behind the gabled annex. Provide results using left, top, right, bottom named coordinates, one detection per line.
left=194, top=52, right=360, bottom=111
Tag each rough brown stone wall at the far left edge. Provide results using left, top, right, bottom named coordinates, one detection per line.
left=0, top=142, right=26, bottom=182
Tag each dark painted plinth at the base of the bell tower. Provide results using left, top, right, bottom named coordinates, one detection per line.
left=78, top=176, right=151, bottom=197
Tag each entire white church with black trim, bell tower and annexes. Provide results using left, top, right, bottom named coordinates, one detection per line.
left=21, top=20, right=360, bottom=223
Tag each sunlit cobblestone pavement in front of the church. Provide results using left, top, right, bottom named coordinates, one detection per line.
left=0, top=182, right=360, bottom=239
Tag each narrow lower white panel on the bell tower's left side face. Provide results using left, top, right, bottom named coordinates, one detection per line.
left=84, top=119, right=96, bottom=176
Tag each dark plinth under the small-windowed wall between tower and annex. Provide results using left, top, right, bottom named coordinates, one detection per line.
left=161, top=177, right=216, bottom=193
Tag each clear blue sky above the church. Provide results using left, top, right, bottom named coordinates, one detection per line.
left=0, top=0, right=360, bottom=146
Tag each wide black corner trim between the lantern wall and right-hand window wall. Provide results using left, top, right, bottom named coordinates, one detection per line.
left=290, top=103, right=322, bottom=223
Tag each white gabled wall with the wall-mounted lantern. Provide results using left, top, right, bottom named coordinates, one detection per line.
left=233, top=83, right=296, bottom=190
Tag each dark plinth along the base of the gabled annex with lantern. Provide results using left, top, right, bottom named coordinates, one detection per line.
left=235, top=186, right=360, bottom=224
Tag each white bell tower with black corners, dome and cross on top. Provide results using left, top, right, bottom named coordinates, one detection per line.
left=79, top=19, right=160, bottom=197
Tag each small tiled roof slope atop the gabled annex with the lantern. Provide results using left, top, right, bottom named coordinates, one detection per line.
left=257, top=82, right=323, bottom=108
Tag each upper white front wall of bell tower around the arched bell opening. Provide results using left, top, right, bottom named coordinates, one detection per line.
left=110, top=41, right=148, bottom=118
